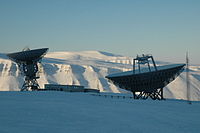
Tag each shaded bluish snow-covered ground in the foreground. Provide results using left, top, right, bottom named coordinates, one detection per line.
left=0, top=91, right=200, bottom=133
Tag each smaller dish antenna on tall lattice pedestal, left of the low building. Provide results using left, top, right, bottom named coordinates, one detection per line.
left=7, top=48, right=48, bottom=91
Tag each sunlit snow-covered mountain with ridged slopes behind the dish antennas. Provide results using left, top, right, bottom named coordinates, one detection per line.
left=0, top=51, right=200, bottom=101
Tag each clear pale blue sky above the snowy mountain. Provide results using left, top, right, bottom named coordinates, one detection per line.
left=0, top=0, right=200, bottom=64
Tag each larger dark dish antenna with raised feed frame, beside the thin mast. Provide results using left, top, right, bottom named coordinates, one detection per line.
left=106, top=55, right=185, bottom=100
